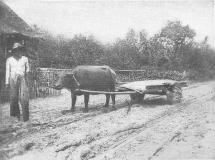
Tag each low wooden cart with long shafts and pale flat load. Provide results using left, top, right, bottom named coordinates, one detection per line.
left=76, top=79, right=187, bottom=104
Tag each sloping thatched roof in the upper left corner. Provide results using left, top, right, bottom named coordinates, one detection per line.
left=0, top=0, right=34, bottom=37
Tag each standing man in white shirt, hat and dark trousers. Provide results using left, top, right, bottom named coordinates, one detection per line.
left=5, top=43, right=29, bottom=121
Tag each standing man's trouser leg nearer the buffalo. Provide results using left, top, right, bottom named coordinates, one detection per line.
left=20, top=77, right=29, bottom=122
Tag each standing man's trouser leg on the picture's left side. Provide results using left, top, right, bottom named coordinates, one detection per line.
left=10, top=79, right=20, bottom=119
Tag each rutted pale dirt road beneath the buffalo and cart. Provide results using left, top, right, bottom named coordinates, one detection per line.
left=0, top=81, right=215, bottom=160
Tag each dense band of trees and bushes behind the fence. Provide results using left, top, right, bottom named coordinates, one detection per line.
left=33, top=21, right=215, bottom=80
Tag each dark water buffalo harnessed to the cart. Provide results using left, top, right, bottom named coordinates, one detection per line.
left=53, top=66, right=116, bottom=112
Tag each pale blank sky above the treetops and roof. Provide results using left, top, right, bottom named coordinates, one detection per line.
left=4, top=0, right=215, bottom=47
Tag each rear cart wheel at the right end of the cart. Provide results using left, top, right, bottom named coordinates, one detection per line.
left=166, top=86, right=182, bottom=104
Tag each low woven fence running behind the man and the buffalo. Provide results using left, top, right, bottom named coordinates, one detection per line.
left=0, top=68, right=184, bottom=103
